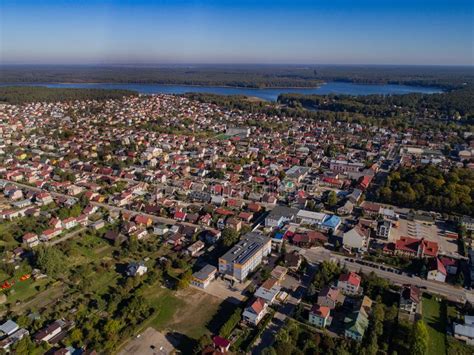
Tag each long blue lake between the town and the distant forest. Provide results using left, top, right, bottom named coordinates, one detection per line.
left=0, top=82, right=443, bottom=101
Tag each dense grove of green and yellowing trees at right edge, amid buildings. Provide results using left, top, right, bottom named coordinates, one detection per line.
left=376, top=165, right=474, bottom=217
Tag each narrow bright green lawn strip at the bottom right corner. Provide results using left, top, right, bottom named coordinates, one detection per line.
left=423, top=295, right=446, bottom=355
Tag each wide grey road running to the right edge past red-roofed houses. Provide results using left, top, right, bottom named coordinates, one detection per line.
left=291, top=246, right=474, bottom=302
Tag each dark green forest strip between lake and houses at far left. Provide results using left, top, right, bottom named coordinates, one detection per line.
left=0, top=86, right=137, bottom=104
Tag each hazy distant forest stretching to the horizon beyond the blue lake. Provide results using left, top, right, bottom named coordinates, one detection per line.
left=0, top=65, right=474, bottom=90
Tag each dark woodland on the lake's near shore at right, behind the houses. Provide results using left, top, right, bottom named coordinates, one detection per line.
left=278, top=86, right=474, bottom=121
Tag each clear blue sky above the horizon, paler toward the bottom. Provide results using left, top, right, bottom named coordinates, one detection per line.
left=0, top=0, right=474, bottom=65
